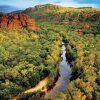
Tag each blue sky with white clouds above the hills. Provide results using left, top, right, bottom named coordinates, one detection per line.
left=0, top=0, right=100, bottom=9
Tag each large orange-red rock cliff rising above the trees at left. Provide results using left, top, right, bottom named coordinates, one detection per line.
left=0, top=13, right=37, bottom=30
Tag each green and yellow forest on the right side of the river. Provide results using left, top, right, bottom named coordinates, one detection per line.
left=58, top=32, right=100, bottom=100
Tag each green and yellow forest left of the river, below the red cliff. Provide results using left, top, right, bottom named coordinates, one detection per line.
left=0, top=26, right=61, bottom=100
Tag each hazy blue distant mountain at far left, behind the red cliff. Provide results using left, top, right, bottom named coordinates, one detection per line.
left=0, top=5, right=18, bottom=13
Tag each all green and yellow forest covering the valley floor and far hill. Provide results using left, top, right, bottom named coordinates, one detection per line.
left=0, top=5, right=100, bottom=100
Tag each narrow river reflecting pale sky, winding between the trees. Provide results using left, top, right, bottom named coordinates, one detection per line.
left=45, top=43, right=72, bottom=100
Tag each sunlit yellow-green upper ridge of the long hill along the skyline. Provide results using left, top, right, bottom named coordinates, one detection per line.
left=23, top=4, right=100, bottom=15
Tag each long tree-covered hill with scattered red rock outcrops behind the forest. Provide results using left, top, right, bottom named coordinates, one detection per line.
left=22, top=4, right=100, bottom=34
